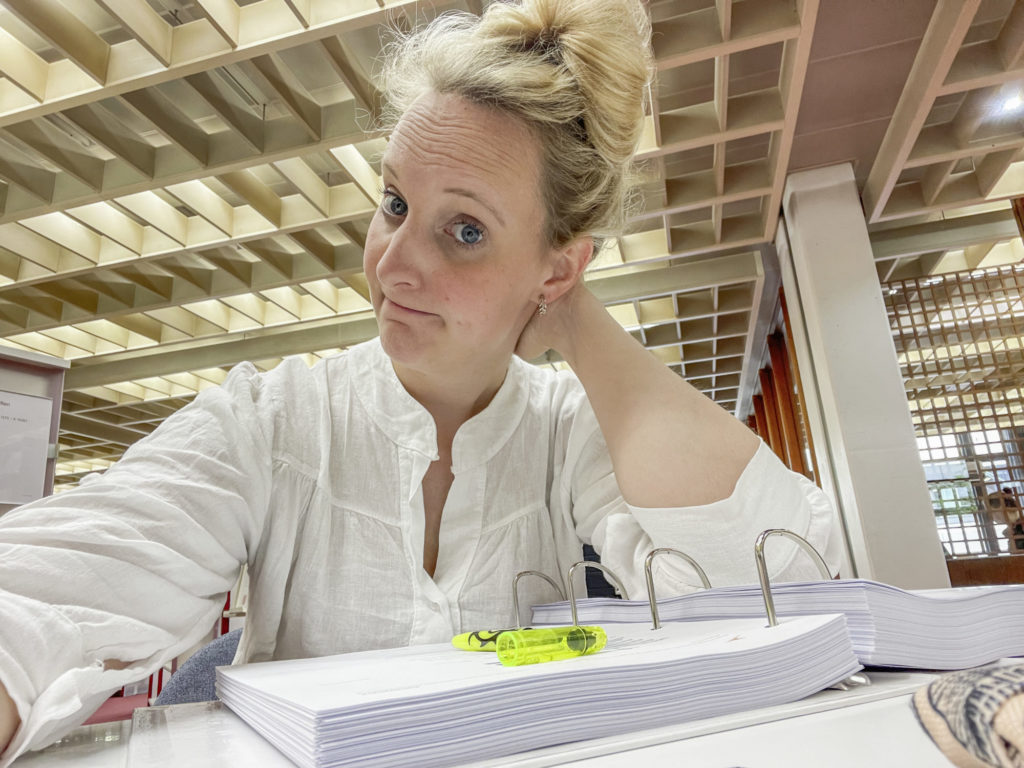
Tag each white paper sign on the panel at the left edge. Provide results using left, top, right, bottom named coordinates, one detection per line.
left=0, top=390, right=53, bottom=504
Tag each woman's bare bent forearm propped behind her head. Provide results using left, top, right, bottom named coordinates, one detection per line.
left=519, top=284, right=758, bottom=507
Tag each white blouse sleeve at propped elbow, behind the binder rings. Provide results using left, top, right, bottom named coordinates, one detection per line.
left=562, top=393, right=842, bottom=599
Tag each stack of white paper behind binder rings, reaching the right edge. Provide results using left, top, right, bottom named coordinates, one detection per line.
left=534, top=579, right=1024, bottom=670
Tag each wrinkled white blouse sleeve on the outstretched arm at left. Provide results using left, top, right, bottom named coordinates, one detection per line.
left=0, top=365, right=276, bottom=768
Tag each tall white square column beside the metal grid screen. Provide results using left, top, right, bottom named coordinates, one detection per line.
left=776, top=164, right=949, bottom=589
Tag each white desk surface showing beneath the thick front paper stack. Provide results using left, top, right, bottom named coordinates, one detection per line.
left=14, top=673, right=950, bottom=768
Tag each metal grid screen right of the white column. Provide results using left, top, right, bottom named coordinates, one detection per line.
left=883, top=264, right=1024, bottom=557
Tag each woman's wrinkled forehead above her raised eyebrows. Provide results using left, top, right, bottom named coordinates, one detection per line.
left=384, top=93, right=541, bottom=200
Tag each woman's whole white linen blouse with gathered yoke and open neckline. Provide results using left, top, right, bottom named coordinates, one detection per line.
left=0, top=340, right=840, bottom=768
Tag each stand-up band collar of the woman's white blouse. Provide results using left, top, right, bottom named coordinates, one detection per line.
left=348, top=338, right=529, bottom=473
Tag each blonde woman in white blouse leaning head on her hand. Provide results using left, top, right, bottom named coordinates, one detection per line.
left=0, top=0, right=839, bottom=765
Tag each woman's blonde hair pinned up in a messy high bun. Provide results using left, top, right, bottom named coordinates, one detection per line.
left=382, top=0, right=651, bottom=247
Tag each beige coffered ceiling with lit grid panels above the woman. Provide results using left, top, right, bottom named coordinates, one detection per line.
left=0, top=0, right=1024, bottom=482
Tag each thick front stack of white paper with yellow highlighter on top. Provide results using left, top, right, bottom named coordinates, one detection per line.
left=217, top=614, right=860, bottom=768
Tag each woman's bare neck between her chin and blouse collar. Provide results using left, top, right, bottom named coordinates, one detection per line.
left=391, top=362, right=508, bottom=440
